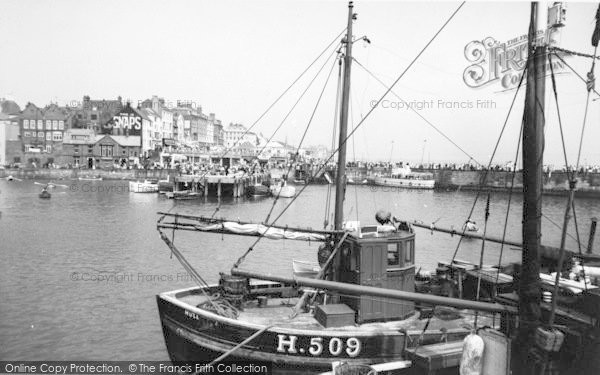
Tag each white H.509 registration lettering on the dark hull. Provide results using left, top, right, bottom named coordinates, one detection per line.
left=277, top=335, right=361, bottom=357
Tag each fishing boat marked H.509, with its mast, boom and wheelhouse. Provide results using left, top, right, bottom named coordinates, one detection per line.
left=157, top=3, right=510, bottom=373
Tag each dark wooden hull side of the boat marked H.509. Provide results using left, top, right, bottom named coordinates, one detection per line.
left=157, top=286, right=466, bottom=373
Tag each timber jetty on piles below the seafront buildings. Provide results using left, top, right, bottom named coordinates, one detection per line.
left=173, top=174, right=268, bottom=198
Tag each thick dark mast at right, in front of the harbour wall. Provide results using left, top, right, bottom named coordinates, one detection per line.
left=519, top=2, right=548, bottom=370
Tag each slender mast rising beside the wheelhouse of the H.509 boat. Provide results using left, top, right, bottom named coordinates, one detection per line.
left=334, top=1, right=354, bottom=230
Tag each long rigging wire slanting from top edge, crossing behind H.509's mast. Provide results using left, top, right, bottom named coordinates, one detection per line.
left=234, top=1, right=465, bottom=268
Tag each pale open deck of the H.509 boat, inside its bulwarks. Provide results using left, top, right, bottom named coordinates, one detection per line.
left=178, top=294, right=482, bottom=333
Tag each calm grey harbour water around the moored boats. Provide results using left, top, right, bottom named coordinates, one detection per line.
left=0, top=180, right=600, bottom=360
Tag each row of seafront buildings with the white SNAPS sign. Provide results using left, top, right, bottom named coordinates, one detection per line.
left=0, top=95, right=314, bottom=169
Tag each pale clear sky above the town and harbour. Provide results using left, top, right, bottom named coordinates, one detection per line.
left=0, top=0, right=600, bottom=165
